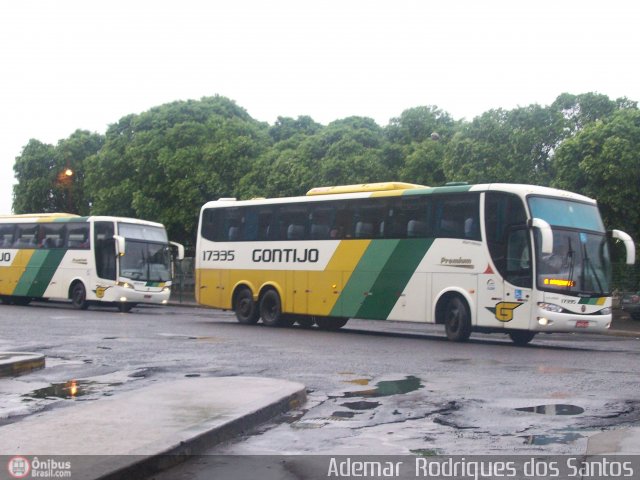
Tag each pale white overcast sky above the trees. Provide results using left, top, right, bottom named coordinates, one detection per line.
left=0, top=0, right=640, bottom=214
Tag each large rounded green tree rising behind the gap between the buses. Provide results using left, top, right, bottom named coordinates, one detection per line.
left=87, top=96, right=271, bottom=246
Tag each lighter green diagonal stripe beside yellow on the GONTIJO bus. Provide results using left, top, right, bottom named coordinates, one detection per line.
left=330, top=240, right=400, bottom=317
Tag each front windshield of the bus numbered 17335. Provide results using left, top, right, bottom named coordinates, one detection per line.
left=529, top=197, right=611, bottom=296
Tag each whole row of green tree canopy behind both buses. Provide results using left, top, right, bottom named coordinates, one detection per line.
left=13, top=93, right=640, bottom=276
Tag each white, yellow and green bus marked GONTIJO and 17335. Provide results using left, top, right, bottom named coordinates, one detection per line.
left=196, top=183, right=635, bottom=344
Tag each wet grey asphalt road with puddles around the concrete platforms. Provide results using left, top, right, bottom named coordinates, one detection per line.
left=0, top=303, right=640, bottom=468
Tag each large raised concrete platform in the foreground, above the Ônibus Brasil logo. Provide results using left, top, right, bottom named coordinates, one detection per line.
left=0, top=377, right=306, bottom=479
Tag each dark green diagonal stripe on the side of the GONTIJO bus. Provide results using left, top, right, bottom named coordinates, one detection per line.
left=355, top=238, right=433, bottom=318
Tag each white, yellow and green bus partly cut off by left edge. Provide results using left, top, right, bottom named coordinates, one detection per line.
left=0, top=213, right=184, bottom=312
